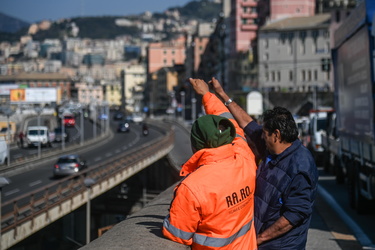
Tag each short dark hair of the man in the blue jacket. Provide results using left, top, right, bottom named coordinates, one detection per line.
left=262, top=107, right=298, bottom=143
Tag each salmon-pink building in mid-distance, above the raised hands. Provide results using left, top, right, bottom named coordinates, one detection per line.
left=148, top=36, right=186, bottom=74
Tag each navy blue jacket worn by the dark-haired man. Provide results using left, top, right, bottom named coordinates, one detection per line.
left=244, top=122, right=318, bottom=250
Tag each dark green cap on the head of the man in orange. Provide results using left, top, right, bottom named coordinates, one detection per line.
left=190, top=115, right=236, bottom=150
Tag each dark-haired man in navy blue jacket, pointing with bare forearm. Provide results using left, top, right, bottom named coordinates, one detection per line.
left=208, top=78, right=318, bottom=250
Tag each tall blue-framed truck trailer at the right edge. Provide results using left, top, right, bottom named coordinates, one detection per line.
left=332, top=0, right=375, bottom=213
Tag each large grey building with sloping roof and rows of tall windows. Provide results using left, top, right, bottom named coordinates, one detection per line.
left=258, top=14, right=332, bottom=91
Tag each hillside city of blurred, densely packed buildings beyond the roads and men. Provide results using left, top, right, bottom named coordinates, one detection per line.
left=0, top=0, right=355, bottom=119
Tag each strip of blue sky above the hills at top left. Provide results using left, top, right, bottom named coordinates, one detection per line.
left=0, top=0, right=191, bottom=23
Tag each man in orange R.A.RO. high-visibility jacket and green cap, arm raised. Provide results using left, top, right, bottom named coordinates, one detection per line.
left=163, top=79, right=257, bottom=250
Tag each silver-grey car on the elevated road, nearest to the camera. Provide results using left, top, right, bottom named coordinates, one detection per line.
left=53, top=154, right=87, bottom=177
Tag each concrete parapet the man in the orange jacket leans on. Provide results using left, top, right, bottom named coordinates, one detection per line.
left=80, top=185, right=190, bottom=250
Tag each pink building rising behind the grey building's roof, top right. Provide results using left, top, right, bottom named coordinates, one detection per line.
left=271, top=0, right=315, bottom=21
